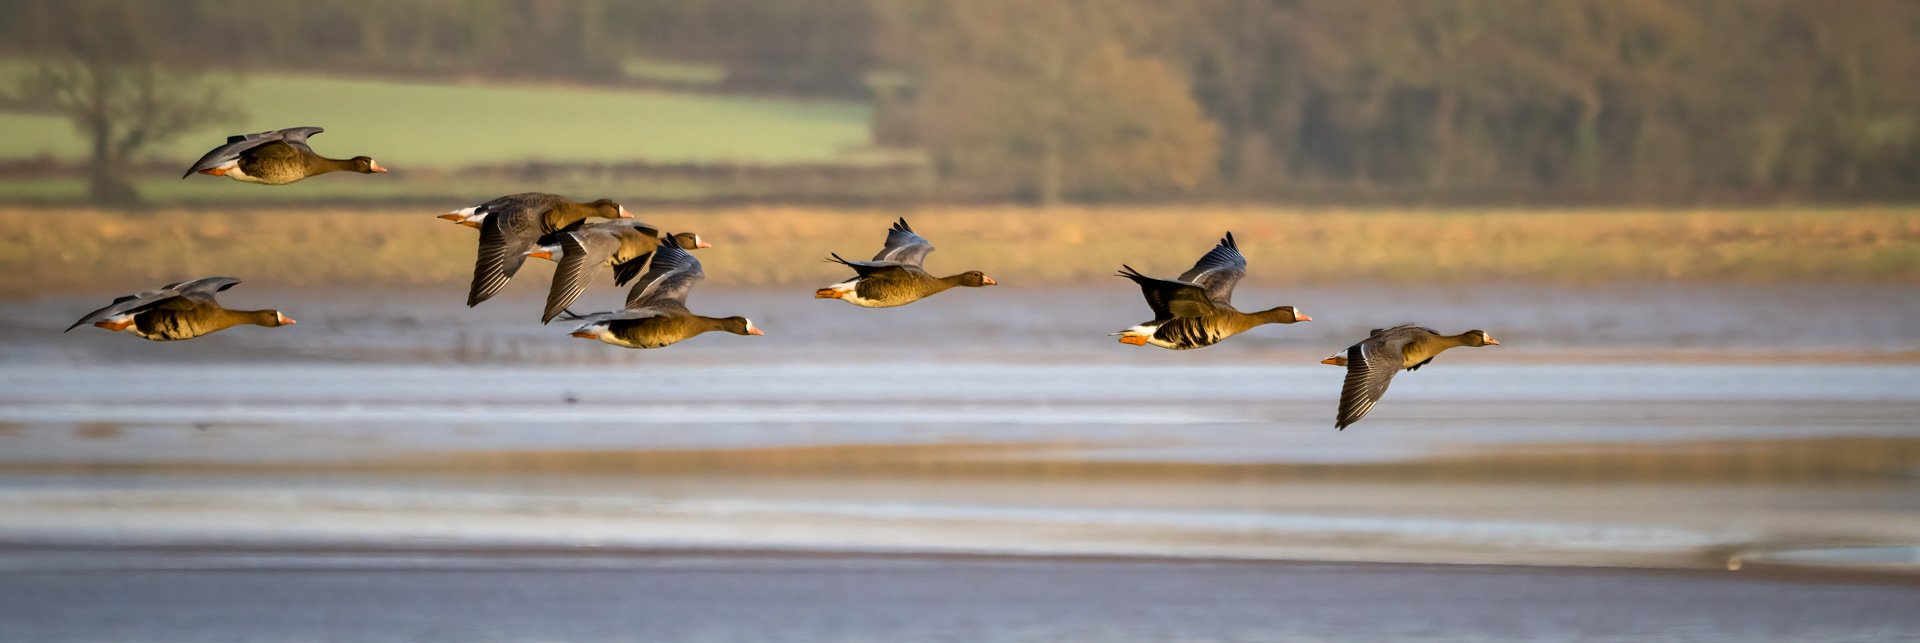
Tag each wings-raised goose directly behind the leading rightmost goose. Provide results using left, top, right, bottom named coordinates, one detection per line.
left=1116, top=232, right=1313, bottom=351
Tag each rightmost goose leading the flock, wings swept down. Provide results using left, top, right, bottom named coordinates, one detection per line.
left=1321, top=324, right=1500, bottom=430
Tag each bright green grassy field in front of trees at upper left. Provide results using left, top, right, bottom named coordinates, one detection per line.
left=0, top=63, right=870, bottom=166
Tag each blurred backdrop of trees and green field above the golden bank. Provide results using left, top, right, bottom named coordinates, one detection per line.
left=0, top=0, right=1920, bottom=203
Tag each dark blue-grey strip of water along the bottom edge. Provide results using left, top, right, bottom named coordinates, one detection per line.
left=0, top=551, right=1920, bottom=641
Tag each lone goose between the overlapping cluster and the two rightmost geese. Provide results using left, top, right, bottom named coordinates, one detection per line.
left=814, top=219, right=996, bottom=309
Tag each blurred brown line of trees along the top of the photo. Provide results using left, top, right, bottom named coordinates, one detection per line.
left=0, top=0, right=1920, bottom=202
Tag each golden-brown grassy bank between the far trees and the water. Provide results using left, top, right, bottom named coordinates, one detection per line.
left=0, top=202, right=1920, bottom=296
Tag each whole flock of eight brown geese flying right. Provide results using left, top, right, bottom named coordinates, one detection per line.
left=67, top=127, right=1500, bottom=430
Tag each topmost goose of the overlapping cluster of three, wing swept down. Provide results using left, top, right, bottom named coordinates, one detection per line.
left=467, top=192, right=634, bottom=307
